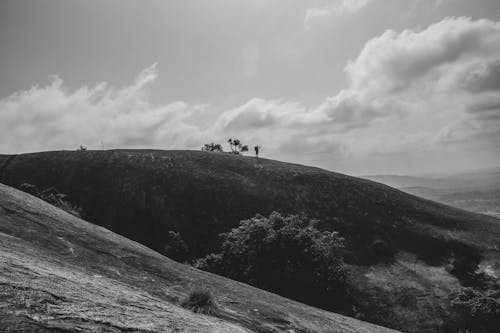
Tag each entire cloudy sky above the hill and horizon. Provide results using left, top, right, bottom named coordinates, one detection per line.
left=0, top=0, right=500, bottom=175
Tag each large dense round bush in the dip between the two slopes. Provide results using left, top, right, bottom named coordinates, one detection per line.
left=195, top=212, right=346, bottom=310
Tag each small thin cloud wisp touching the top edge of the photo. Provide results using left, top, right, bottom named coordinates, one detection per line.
left=304, top=0, right=373, bottom=29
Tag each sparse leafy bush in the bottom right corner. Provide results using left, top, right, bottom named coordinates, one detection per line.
left=452, top=288, right=500, bottom=333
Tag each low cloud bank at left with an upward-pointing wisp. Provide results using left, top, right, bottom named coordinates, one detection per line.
left=0, top=65, right=205, bottom=153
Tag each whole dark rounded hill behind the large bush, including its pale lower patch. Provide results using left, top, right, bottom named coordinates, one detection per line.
left=0, top=150, right=500, bottom=332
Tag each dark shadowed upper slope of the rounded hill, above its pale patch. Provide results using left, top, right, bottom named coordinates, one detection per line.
left=0, top=150, right=500, bottom=259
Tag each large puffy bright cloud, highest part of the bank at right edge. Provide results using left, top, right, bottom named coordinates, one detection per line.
left=346, top=17, right=500, bottom=93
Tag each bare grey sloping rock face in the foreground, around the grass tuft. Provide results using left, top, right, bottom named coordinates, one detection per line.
left=0, top=184, right=394, bottom=333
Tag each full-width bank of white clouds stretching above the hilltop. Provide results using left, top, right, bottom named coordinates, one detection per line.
left=0, top=17, right=500, bottom=169
